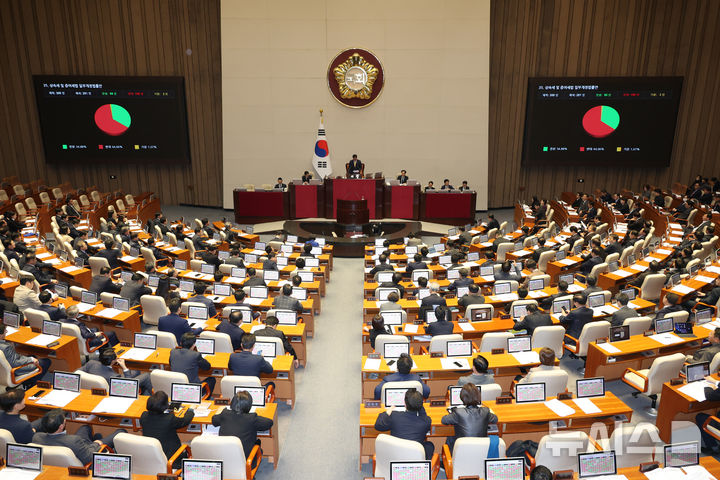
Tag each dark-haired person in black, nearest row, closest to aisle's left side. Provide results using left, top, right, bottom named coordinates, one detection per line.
left=212, top=390, right=273, bottom=468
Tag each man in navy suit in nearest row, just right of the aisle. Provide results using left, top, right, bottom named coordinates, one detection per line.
left=375, top=389, right=435, bottom=460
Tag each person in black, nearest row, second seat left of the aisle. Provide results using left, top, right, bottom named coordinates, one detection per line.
left=140, top=390, right=195, bottom=468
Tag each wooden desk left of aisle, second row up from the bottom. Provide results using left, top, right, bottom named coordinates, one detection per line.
left=110, top=344, right=295, bottom=407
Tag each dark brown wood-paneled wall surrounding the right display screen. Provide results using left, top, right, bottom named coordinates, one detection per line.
left=489, top=0, right=720, bottom=207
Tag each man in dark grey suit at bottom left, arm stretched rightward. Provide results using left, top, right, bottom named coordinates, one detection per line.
left=33, top=408, right=126, bottom=465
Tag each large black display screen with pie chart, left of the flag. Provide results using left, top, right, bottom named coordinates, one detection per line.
left=33, top=75, right=190, bottom=164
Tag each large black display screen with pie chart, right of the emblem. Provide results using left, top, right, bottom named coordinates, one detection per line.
left=523, top=77, right=682, bottom=167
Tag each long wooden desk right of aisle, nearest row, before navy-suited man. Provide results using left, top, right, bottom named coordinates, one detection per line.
left=360, top=392, right=637, bottom=464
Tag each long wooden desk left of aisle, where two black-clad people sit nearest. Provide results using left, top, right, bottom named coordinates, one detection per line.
left=23, top=387, right=280, bottom=468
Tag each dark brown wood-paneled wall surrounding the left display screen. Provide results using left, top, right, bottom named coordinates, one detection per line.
left=0, top=0, right=222, bottom=205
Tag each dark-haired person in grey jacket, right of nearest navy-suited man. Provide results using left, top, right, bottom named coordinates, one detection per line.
left=441, top=383, right=497, bottom=452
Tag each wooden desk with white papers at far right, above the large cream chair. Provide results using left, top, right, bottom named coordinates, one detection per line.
left=585, top=325, right=711, bottom=380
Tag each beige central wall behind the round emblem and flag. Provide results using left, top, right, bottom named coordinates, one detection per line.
left=221, top=0, right=490, bottom=209
